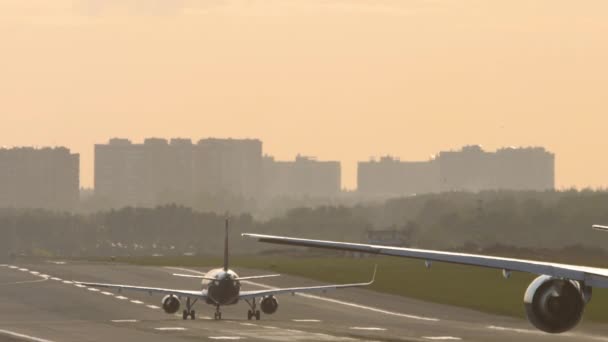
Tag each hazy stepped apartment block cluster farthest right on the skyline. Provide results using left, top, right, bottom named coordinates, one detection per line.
left=357, top=145, right=555, bottom=196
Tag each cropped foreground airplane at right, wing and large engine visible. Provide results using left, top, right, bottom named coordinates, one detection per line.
left=242, top=225, right=608, bottom=334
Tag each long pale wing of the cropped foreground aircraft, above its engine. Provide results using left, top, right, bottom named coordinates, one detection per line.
left=243, top=234, right=608, bottom=288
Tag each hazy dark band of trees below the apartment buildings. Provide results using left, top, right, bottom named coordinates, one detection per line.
left=0, top=191, right=608, bottom=262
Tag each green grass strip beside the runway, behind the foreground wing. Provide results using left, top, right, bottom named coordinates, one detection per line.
left=86, top=256, right=608, bottom=322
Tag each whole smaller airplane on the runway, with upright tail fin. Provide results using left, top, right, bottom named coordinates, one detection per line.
left=74, top=219, right=376, bottom=320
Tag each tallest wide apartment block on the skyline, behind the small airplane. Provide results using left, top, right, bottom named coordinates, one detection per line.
left=95, top=138, right=262, bottom=206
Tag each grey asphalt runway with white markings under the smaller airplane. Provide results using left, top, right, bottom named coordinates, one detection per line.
left=0, top=260, right=608, bottom=342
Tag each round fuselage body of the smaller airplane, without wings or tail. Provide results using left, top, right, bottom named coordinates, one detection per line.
left=201, top=268, right=241, bottom=305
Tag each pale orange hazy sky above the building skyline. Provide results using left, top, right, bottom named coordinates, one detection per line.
left=0, top=0, right=608, bottom=188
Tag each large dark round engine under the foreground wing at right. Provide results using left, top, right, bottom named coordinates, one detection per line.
left=524, top=275, right=590, bottom=334
